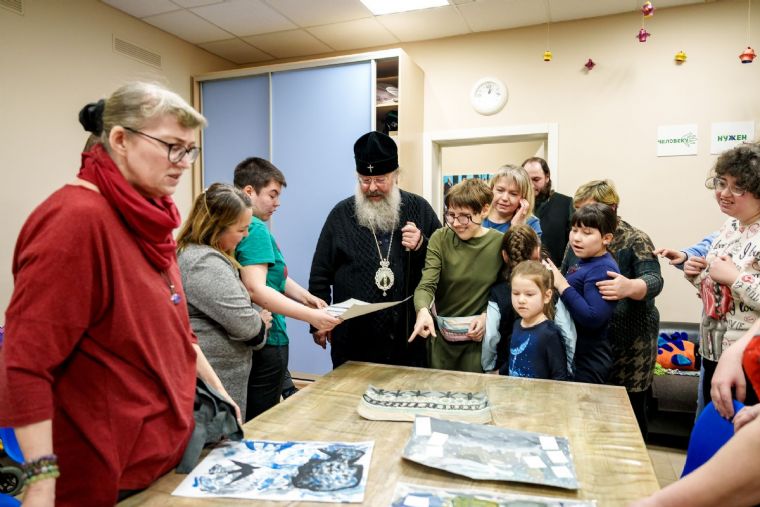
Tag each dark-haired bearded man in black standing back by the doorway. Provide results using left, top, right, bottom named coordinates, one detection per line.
left=522, top=157, right=573, bottom=266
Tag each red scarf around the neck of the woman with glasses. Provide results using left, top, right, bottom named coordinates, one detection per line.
left=79, top=144, right=180, bottom=271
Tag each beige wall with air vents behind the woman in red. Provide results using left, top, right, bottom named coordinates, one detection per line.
left=0, top=0, right=234, bottom=323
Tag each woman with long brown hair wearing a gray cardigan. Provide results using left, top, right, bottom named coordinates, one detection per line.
left=177, top=183, right=272, bottom=419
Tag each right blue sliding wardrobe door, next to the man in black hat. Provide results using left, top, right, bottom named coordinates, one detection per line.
left=271, top=61, right=374, bottom=374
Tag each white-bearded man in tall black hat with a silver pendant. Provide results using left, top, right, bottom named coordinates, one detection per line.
left=309, top=132, right=441, bottom=368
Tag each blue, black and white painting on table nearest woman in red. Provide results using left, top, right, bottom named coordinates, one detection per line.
left=172, top=440, right=374, bottom=503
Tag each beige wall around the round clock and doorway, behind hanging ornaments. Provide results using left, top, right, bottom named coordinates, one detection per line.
left=404, top=0, right=760, bottom=321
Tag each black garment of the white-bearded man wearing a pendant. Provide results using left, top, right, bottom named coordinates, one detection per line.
left=309, top=190, right=441, bottom=368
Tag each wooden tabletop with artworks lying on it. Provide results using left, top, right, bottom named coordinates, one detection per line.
left=119, top=362, right=659, bottom=507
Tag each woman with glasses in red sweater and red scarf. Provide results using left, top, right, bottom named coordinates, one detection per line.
left=0, top=83, right=236, bottom=506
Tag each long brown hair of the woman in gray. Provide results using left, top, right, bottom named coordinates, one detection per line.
left=177, top=183, right=251, bottom=265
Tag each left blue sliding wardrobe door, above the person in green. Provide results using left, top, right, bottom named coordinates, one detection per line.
left=201, top=74, right=270, bottom=188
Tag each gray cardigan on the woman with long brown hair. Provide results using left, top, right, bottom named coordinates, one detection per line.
left=177, top=244, right=265, bottom=417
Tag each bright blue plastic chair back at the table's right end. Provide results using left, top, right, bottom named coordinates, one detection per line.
left=681, top=400, right=744, bottom=478
